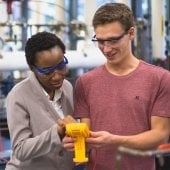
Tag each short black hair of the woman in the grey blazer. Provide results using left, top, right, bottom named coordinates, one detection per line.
left=25, top=32, right=65, bottom=69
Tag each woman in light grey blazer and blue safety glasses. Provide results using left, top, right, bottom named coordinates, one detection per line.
left=6, top=32, right=73, bottom=170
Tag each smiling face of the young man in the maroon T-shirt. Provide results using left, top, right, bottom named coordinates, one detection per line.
left=93, top=22, right=134, bottom=64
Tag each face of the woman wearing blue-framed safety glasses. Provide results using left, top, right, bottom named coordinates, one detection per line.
left=33, top=47, right=67, bottom=92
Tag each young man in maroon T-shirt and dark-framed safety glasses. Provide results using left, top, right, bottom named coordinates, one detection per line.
left=63, top=3, right=170, bottom=170
